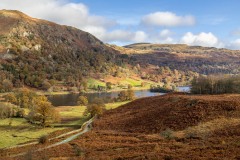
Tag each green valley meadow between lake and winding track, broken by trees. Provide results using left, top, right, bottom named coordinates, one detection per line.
left=0, top=102, right=128, bottom=148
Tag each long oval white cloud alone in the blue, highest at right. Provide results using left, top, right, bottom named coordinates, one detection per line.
left=142, top=12, right=195, bottom=27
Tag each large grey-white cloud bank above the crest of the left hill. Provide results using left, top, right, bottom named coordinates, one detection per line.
left=0, top=0, right=116, bottom=37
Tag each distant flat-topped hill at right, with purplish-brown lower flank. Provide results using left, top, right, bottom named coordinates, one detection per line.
left=113, top=43, right=240, bottom=74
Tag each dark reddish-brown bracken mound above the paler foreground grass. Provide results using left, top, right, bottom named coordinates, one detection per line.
left=94, top=93, right=240, bottom=133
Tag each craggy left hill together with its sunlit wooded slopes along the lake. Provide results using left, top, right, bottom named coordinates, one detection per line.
left=0, top=10, right=201, bottom=92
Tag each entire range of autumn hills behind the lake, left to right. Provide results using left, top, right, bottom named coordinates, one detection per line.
left=0, top=10, right=240, bottom=92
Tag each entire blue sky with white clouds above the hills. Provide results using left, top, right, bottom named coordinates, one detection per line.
left=0, top=0, right=240, bottom=49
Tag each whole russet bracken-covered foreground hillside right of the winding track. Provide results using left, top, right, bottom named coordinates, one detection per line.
left=2, top=93, right=240, bottom=160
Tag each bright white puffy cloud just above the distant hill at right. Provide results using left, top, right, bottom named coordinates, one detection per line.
left=180, top=32, right=224, bottom=48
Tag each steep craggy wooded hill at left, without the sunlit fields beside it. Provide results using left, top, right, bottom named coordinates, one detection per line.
left=0, top=10, right=127, bottom=87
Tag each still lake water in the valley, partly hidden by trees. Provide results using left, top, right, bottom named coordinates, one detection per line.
left=48, top=87, right=190, bottom=106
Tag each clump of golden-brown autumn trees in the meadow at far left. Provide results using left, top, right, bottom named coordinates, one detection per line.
left=4, top=89, right=59, bottom=126
